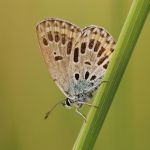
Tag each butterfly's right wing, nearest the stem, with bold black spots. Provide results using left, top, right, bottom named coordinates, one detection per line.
left=69, top=25, right=115, bottom=92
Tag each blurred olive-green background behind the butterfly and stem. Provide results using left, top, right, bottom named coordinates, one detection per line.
left=0, top=0, right=150, bottom=150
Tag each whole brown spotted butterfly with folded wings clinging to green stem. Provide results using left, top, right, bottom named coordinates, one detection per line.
left=36, top=18, right=115, bottom=120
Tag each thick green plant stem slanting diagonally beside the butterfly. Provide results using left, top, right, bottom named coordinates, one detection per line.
left=73, top=0, right=150, bottom=150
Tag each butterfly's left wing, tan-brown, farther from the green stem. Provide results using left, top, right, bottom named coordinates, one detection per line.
left=36, top=18, right=81, bottom=96
